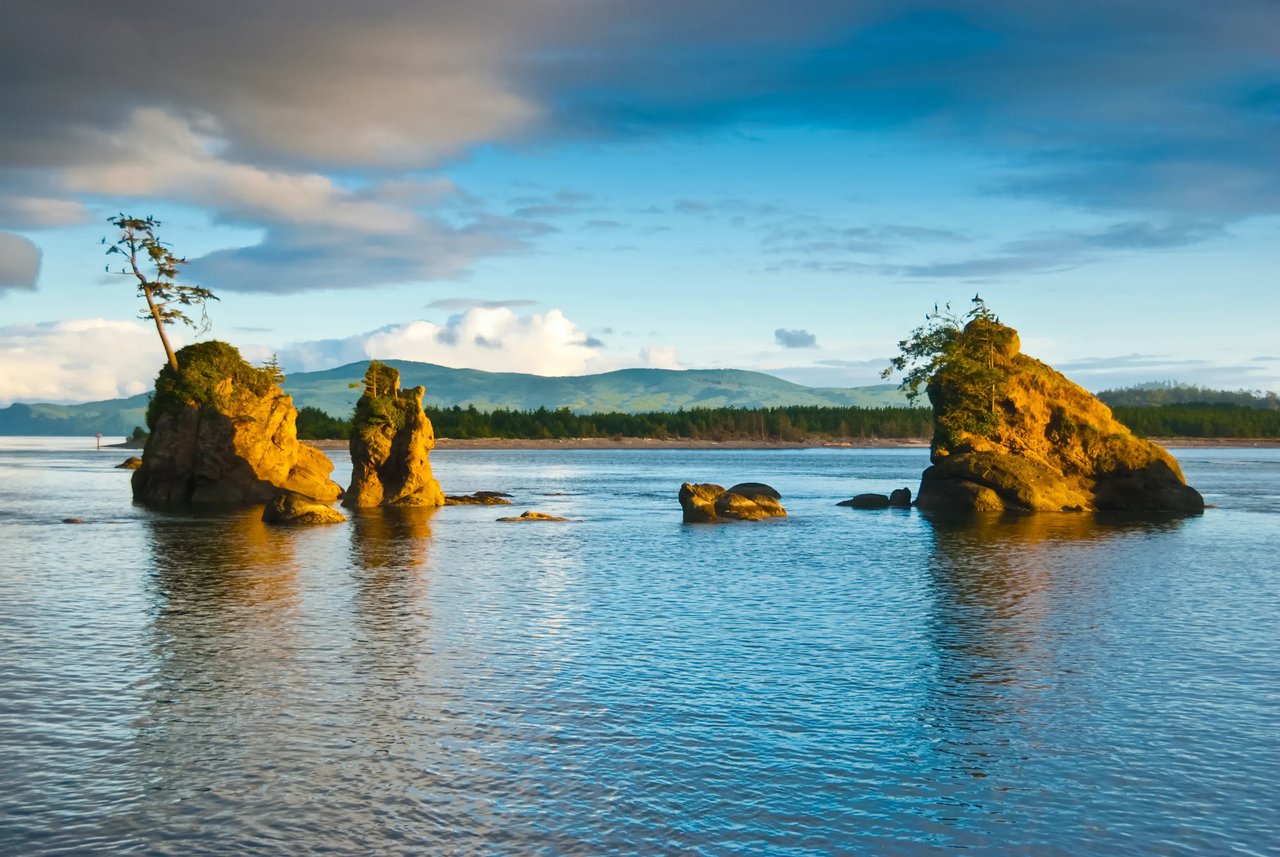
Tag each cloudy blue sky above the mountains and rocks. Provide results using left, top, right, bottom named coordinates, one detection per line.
left=0, top=0, right=1280, bottom=405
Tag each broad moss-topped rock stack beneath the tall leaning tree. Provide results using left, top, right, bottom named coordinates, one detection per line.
left=133, top=342, right=342, bottom=505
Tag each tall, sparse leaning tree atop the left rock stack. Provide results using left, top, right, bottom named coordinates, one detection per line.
left=102, top=214, right=218, bottom=372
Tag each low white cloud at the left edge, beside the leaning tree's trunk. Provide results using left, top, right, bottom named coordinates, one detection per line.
left=0, top=318, right=172, bottom=405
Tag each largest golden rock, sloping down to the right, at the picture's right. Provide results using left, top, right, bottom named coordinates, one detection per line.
left=916, top=321, right=1204, bottom=513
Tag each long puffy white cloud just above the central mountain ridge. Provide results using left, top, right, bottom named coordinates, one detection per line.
left=279, top=307, right=602, bottom=375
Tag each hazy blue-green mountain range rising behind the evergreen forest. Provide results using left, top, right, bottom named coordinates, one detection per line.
left=0, top=361, right=906, bottom=437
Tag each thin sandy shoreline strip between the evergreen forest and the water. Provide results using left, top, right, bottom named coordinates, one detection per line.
left=302, top=437, right=1280, bottom=450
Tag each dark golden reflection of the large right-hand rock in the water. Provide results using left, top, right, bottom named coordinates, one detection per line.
left=922, top=513, right=1181, bottom=789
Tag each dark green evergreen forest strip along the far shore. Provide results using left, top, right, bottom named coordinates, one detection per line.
left=298, top=403, right=1280, bottom=441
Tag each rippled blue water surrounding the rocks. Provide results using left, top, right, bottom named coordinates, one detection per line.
left=0, top=437, right=1280, bottom=854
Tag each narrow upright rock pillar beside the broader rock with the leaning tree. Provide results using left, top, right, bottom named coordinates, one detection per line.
left=342, top=361, right=444, bottom=508
